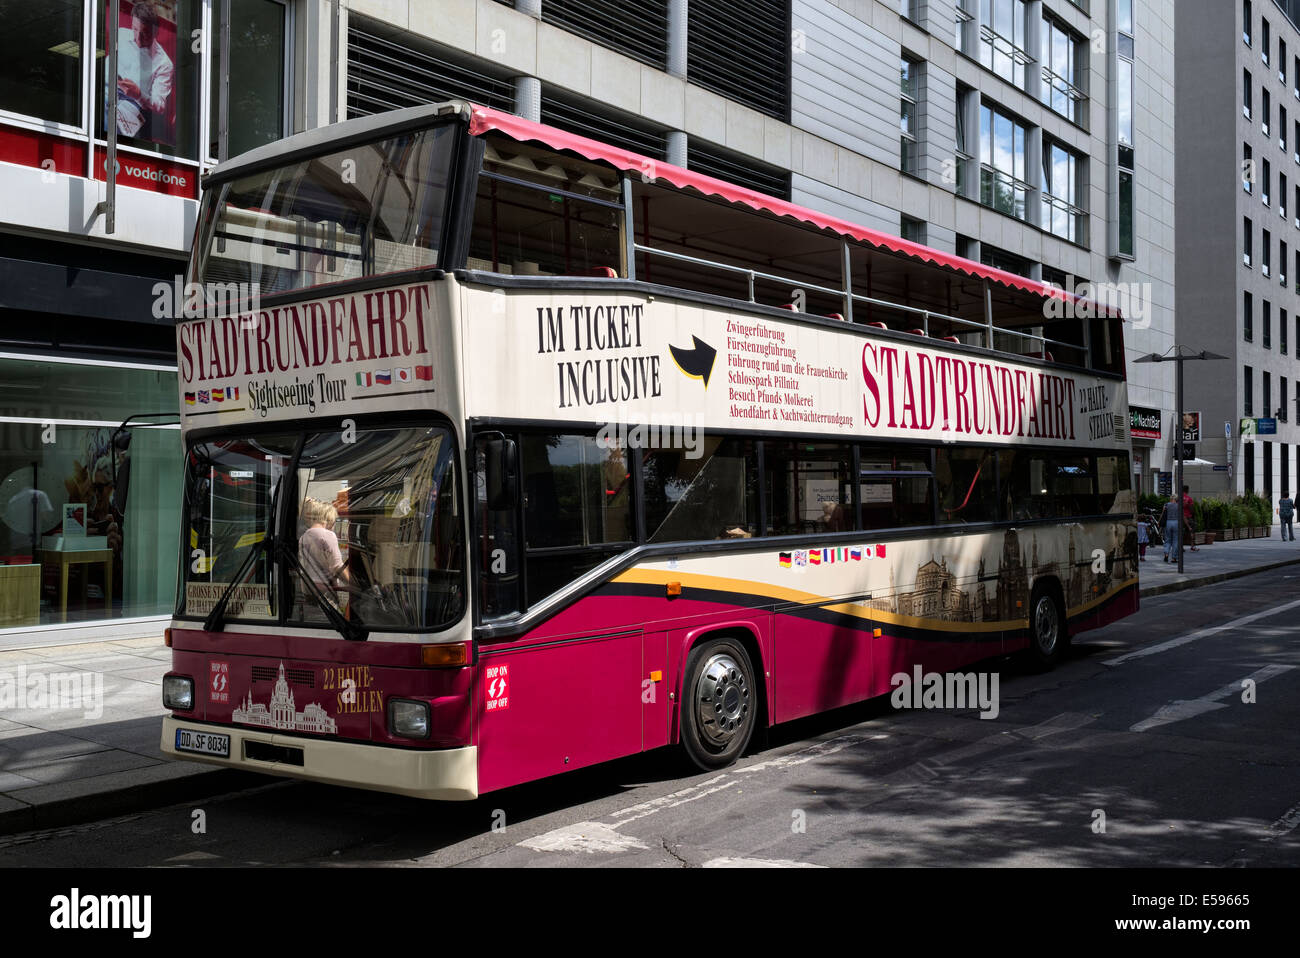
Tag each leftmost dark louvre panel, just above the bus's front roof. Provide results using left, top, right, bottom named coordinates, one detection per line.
left=347, top=17, right=515, bottom=120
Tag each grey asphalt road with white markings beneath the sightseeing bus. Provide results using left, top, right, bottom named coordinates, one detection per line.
left=0, top=571, right=1300, bottom=868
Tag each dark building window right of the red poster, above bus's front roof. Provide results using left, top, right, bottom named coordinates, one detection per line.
left=207, top=0, right=287, bottom=159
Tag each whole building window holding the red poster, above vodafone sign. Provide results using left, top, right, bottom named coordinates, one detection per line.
left=95, top=0, right=203, bottom=160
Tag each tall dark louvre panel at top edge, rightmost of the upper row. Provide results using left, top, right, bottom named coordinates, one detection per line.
left=686, top=0, right=790, bottom=120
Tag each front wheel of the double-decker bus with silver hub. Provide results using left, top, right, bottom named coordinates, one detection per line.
left=681, top=638, right=759, bottom=771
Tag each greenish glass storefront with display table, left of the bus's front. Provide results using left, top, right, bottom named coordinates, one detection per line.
left=0, top=359, right=182, bottom=629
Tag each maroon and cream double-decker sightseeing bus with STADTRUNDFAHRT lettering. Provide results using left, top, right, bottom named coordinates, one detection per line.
left=163, top=103, right=1138, bottom=799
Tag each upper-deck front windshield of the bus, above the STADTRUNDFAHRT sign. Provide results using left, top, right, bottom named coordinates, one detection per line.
left=196, top=123, right=455, bottom=295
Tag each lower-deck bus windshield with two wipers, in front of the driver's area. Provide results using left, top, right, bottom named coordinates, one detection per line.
left=181, top=426, right=464, bottom=630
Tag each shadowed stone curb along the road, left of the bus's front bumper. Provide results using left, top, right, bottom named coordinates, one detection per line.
left=0, top=768, right=276, bottom=836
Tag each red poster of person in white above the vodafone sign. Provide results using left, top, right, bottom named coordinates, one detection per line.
left=105, top=0, right=177, bottom=147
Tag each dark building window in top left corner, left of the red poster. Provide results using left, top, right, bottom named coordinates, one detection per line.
left=0, top=0, right=86, bottom=126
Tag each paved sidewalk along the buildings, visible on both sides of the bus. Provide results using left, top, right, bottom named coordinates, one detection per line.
left=0, top=534, right=1300, bottom=835
